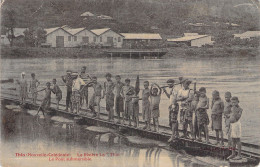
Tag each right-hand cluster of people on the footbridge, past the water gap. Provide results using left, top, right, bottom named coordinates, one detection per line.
left=163, top=79, right=243, bottom=159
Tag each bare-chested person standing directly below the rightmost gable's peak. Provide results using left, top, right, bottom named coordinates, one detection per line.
left=104, top=73, right=115, bottom=121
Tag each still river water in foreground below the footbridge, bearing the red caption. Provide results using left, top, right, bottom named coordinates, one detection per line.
left=0, top=103, right=229, bottom=167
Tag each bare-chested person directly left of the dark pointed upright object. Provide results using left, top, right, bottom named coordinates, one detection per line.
left=120, top=78, right=135, bottom=126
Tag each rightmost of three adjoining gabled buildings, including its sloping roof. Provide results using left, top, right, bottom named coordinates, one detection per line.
left=91, top=28, right=124, bottom=48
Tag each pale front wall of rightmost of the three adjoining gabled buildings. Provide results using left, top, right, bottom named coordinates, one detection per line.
left=96, top=30, right=123, bottom=48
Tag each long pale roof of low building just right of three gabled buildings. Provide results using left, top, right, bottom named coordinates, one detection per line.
left=121, top=33, right=162, bottom=39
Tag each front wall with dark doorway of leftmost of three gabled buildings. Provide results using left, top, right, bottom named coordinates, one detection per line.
left=46, top=29, right=73, bottom=47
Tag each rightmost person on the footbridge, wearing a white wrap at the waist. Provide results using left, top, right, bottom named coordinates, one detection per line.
left=227, top=97, right=243, bottom=160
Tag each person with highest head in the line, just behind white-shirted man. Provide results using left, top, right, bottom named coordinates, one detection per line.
left=80, top=66, right=92, bottom=107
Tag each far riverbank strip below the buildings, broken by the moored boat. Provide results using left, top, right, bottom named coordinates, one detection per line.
left=1, top=47, right=259, bottom=59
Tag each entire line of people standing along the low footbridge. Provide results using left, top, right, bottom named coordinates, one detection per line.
left=18, top=66, right=243, bottom=159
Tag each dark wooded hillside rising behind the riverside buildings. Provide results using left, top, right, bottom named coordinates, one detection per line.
left=1, top=0, right=259, bottom=35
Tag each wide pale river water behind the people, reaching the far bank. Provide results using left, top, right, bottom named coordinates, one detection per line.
left=1, top=57, right=260, bottom=144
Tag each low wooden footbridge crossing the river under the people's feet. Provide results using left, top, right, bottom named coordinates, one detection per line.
left=1, top=92, right=260, bottom=164
